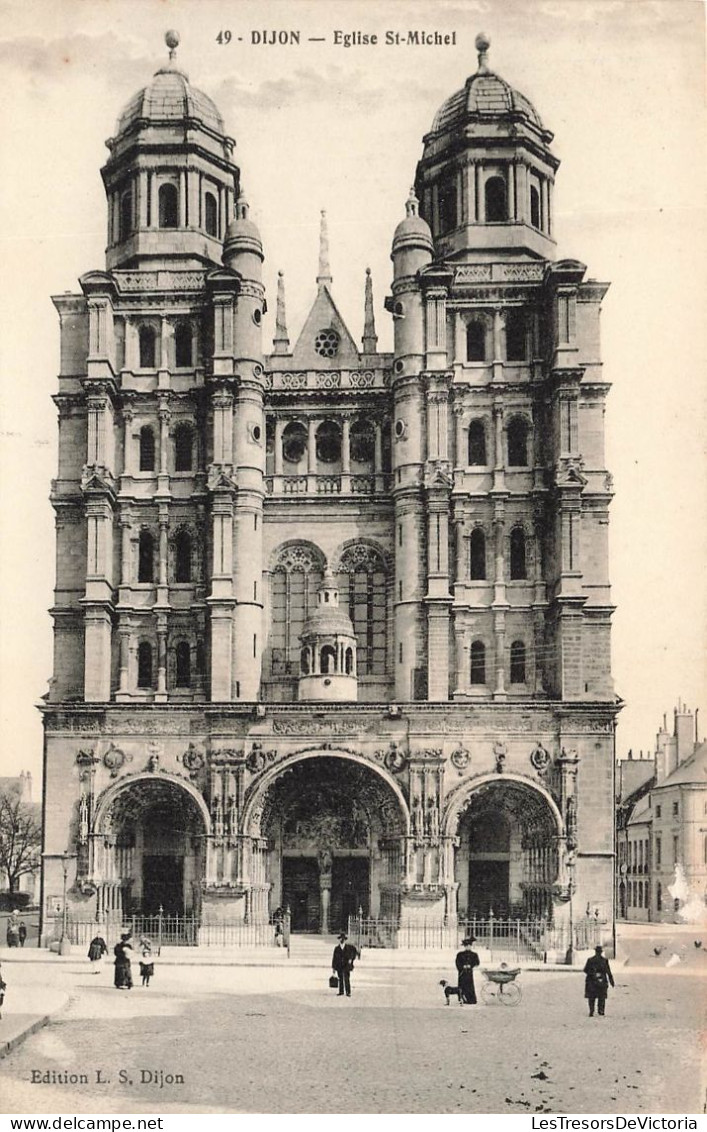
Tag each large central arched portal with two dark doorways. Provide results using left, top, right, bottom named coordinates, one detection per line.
left=244, top=753, right=407, bottom=933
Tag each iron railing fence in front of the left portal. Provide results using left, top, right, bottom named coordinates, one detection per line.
left=67, top=914, right=290, bottom=954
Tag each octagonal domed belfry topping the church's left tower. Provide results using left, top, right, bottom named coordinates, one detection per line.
left=101, top=31, right=239, bottom=271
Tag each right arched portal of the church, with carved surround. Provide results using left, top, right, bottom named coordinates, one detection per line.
left=446, top=775, right=563, bottom=919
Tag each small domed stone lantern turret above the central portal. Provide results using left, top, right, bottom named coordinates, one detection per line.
left=299, top=571, right=357, bottom=702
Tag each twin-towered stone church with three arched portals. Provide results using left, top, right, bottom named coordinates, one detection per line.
left=42, top=33, right=620, bottom=932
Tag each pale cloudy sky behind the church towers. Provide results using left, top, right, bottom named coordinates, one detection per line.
left=0, top=0, right=707, bottom=777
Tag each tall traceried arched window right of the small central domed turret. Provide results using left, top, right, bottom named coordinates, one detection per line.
left=337, top=543, right=387, bottom=676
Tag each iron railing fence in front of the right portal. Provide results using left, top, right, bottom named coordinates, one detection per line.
left=348, top=916, right=606, bottom=961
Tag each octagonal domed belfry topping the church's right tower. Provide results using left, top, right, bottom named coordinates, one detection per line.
left=415, top=34, right=560, bottom=261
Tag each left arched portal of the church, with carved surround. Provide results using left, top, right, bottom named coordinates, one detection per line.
left=92, top=774, right=209, bottom=916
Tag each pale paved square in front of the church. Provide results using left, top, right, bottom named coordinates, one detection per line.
left=2, top=940, right=707, bottom=1113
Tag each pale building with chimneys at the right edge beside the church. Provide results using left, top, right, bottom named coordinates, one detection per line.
left=617, top=704, right=707, bottom=923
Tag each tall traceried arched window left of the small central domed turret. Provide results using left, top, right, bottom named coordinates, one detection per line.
left=270, top=544, right=324, bottom=676
